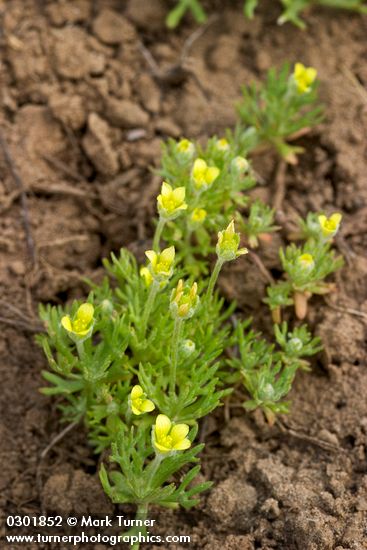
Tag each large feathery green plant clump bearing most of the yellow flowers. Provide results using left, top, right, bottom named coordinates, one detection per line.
left=37, top=62, right=341, bottom=548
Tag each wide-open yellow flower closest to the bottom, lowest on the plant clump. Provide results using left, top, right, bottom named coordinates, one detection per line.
left=153, top=414, right=191, bottom=454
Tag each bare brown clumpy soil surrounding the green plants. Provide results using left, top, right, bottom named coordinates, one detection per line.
left=0, top=0, right=367, bottom=550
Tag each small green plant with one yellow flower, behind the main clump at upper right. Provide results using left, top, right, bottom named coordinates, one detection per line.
left=237, top=63, right=322, bottom=164
